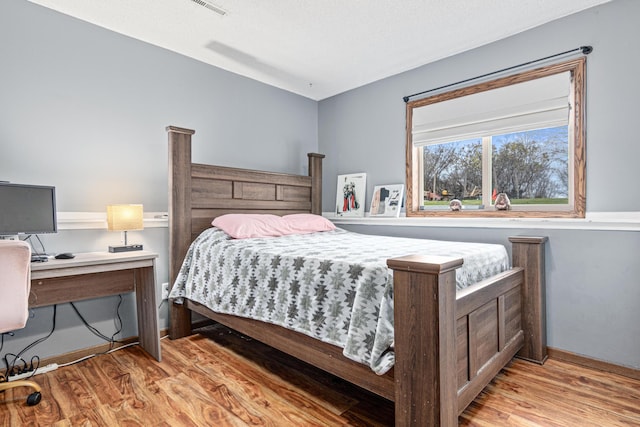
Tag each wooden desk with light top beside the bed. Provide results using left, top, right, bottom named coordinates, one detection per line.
left=29, top=251, right=160, bottom=361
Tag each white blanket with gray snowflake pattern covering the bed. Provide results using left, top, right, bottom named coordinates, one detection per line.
left=170, top=227, right=509, bottom=375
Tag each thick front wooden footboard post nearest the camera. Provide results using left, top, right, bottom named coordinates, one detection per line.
left=387, top=255, right=462, bottom=426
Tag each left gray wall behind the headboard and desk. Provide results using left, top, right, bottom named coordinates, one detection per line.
left=0, top=0, right=317, bottom=364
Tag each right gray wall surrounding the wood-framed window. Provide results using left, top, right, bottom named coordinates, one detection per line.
left=318, top=0, right=640, bottom=368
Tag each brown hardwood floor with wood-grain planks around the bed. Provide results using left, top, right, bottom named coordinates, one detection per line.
left=0, top=326, right=640, bottom=427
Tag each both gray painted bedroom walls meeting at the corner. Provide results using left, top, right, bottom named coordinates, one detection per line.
left=0, top=0, right=640, bottom=368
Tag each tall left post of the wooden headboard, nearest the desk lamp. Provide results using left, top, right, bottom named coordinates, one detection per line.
left=167, top=126, right=195, bottom=339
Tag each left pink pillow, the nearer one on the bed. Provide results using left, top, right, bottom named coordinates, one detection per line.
left=211, top=214, right=291, bottom=239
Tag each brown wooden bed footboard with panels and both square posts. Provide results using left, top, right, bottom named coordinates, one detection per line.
left=387, top=237, right=546, bottom=426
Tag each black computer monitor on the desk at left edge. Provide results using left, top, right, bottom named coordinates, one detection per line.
left=0, top=183, right=58, bottom=236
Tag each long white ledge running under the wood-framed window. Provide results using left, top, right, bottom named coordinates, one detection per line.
left=323, top=212, right=640, bottom=231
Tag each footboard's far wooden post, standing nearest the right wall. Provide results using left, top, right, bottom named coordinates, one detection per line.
left=509, top=236, right=547, bottom=364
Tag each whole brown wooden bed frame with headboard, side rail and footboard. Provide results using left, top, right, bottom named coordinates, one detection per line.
left=167, top=126, right=547, bottom=426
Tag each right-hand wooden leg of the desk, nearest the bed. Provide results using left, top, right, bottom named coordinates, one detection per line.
left=135, top=261, right=160, bottom=362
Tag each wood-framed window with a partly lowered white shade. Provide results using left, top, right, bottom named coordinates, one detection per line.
left=407, top=58, right=585, bottom=217
